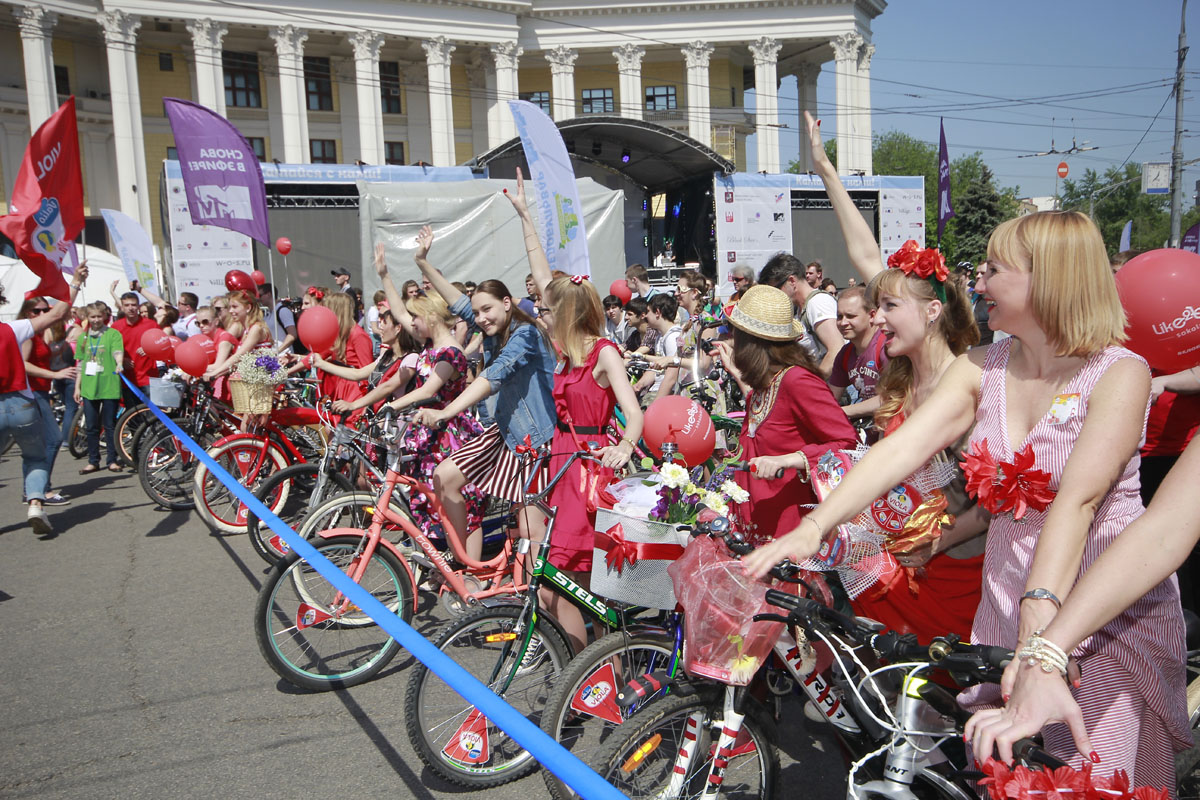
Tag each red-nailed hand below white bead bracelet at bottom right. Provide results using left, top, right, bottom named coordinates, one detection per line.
left=964, top=658, right=1098, bottom=764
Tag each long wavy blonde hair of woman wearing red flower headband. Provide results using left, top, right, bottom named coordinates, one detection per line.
left=868, top=270, right=979, bottom=429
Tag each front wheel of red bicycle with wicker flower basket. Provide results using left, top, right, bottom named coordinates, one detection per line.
left=192, top=437, right=288, bottom=534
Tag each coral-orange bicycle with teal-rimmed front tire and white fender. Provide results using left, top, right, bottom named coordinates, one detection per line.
left=254, top=404, right=535, bottom=691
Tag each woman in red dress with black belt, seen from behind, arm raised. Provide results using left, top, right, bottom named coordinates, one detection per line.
left=505, top=169, right=642, bottom=652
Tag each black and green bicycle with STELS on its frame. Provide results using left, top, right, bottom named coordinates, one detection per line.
left=404, top=446, right=674, bottom=788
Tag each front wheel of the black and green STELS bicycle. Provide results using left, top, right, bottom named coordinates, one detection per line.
left=404, top=606, right=570, bottom=789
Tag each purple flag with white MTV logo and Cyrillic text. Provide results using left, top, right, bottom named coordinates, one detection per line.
left=162, top=97, right=271, bottom=247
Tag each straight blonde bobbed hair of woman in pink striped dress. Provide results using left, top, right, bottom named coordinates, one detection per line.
left=988, top=211, right=1126, bottom=357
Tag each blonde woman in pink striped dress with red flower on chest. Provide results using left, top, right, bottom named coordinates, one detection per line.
left=746, top=211, right=1190, bottom=787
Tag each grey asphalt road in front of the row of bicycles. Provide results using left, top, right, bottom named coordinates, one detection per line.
left=0, top=451, right=845, bottom=800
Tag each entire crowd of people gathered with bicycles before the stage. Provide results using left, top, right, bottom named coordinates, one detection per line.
left=0, top=110, right=1200, bottom=787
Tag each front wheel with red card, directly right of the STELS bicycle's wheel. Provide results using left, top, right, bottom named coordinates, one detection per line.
left=541, top=630, right=674, bottom=800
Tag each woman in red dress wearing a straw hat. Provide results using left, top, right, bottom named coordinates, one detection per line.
left=714, top=285, right=857, bottom=539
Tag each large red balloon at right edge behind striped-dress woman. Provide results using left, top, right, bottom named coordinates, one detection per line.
left=1117, top=249, right=1200, bottom=373
